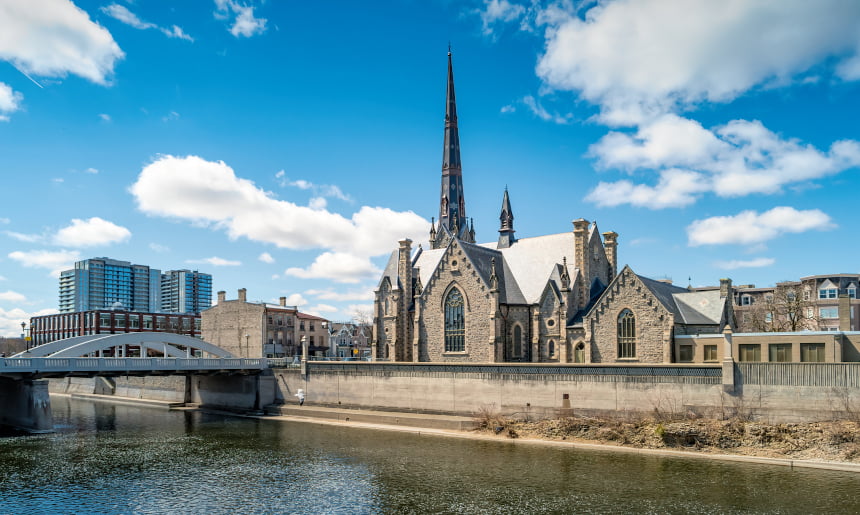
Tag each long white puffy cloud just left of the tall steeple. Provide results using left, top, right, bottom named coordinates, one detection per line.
left=130, top=156, right=429, bottom=280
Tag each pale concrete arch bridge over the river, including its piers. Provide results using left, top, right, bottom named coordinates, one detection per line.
left=0, top=333, right=274, bottom=431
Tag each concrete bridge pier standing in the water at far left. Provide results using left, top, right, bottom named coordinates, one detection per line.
left=0, top=377, right=54, bottom=433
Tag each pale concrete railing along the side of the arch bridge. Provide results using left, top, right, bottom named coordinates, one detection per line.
left=0, top=357, right=267, bottom=375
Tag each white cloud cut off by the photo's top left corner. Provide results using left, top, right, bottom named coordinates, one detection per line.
left=0, top=0, right=125, bottom=84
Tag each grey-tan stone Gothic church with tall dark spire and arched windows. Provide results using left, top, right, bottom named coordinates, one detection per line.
left=372, top=52, right=732, bottom=363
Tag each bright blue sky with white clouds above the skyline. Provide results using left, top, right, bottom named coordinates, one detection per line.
left=0, top=0, right=860, bottom=335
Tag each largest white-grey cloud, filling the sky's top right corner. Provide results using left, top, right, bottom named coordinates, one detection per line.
left=537, top=0, right=860, bottom=125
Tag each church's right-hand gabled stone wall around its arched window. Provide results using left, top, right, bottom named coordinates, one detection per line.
left=585, top=268, right=674, bottom=363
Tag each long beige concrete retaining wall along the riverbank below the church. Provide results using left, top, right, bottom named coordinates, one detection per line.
left=275, top=362, right=860, bottom=422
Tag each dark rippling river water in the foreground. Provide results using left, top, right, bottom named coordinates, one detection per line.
left=0, top=398, right=860, bottom=514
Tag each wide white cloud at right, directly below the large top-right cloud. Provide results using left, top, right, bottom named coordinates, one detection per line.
left=586, top=114, right=860, bottom=209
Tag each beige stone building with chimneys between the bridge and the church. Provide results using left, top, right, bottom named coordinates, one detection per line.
left=200, top=288, right=328, bottom=358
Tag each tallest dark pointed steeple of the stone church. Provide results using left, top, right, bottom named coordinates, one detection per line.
left=433, top=48, right=475, bottom=248
